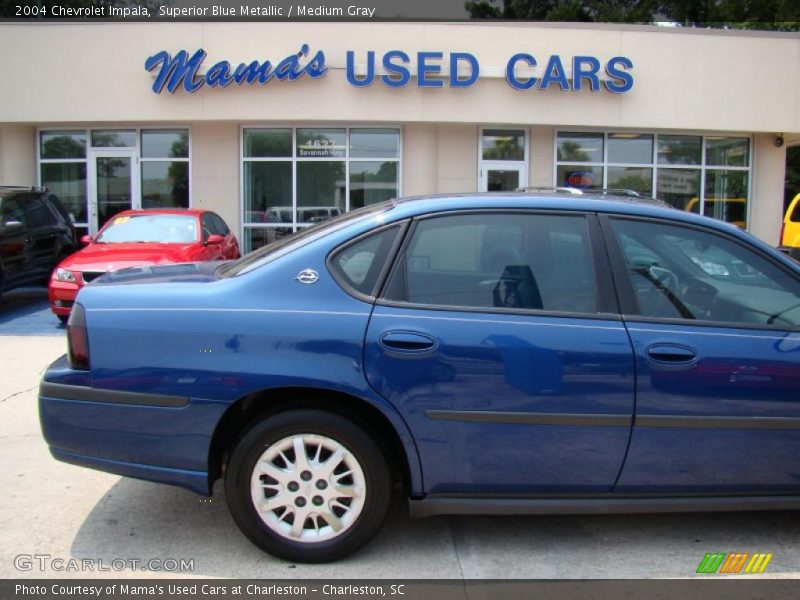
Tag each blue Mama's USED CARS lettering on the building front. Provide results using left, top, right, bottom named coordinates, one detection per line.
left=144, top=44, right=633, bottom=94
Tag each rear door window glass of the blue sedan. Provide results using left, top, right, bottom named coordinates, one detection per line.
left=386, top=214, right=597, bottom=313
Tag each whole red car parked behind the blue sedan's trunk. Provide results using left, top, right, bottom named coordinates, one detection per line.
left=50, top=209, right=240, bottom=322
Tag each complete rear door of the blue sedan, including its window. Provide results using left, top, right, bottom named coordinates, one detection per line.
left=365, top=212, right=634, bottom=494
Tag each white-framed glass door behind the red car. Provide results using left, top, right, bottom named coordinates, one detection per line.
left=89, top=149, right=140, bottom=234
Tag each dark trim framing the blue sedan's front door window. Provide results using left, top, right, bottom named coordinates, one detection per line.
left=598, top=213, right=800, bottom=332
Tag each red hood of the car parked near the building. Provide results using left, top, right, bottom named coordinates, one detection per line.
left=59, top=242, right=198, bottom=271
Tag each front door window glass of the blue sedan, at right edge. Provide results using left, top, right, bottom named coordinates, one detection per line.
left=612, top=219, right=800, bottom=328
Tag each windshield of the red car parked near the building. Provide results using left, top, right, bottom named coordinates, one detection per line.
left=95, top=215, right=198, bottom=244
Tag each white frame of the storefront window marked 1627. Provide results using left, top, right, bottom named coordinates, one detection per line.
left=239, top=122, right=404, bottom=251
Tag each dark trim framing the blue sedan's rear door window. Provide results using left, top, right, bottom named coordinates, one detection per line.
left=375, top=208, right=622, bottom=321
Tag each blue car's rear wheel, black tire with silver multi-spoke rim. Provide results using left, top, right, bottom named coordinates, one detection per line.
left=225, top=410, right=391, bottom=563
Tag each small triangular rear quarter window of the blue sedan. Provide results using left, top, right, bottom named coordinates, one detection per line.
left=329, top=226, right=400, bottom=296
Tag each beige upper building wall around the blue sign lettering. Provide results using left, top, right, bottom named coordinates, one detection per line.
left=0, top=22, right=800, bottom=132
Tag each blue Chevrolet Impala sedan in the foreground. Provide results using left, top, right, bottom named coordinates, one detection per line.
left=39, top=192, right=800, bottom=561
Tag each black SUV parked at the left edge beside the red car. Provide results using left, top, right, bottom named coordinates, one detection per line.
left=0, top=186, right=77, bottom=295
